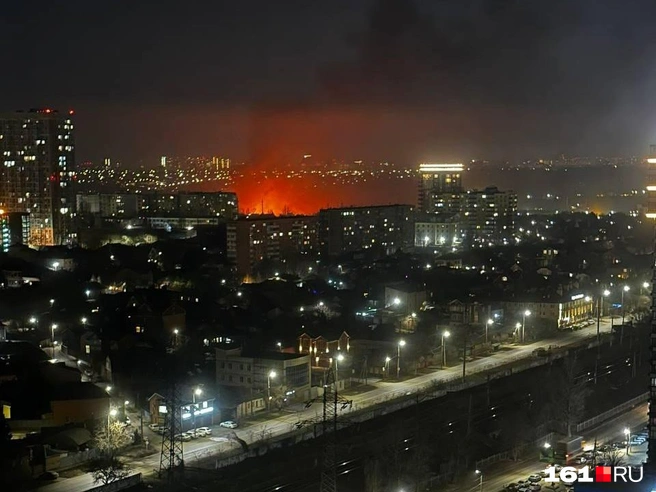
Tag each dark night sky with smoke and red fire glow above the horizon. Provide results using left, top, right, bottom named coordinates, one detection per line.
left=0, top=0, right=656, bottom=165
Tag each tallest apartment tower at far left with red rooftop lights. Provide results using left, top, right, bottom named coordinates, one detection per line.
left=0, top=109, right=75, bottom=246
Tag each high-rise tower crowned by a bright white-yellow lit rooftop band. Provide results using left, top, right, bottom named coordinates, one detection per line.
left=417, top=164, right=464, bottom=213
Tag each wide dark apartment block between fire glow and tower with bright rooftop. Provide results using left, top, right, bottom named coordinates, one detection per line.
left=319, top=205, right=414, bottom=256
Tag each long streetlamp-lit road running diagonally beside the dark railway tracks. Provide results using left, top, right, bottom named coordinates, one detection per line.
left=39, top=319, right=610, bottom=492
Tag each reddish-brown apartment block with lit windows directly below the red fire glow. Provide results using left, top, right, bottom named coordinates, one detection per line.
left=227, top=215, right=318, bottom=276
